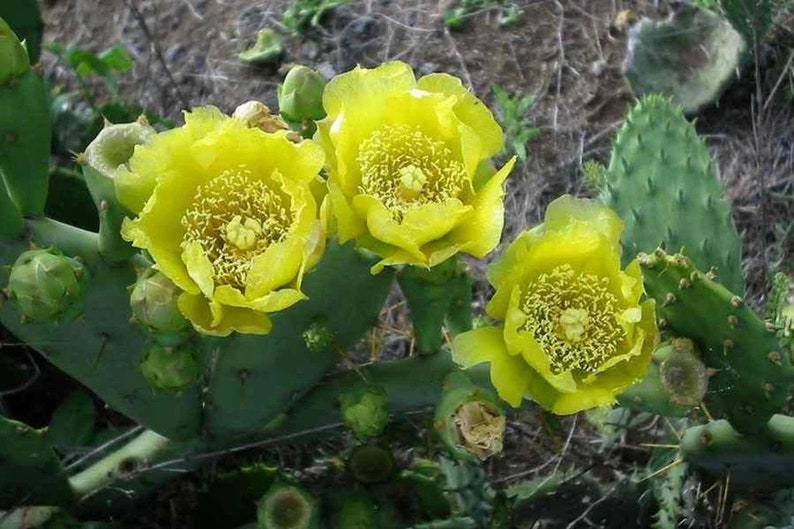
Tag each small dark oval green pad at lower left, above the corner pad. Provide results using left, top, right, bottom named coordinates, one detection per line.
left=47, top=389, right=96, bottom=452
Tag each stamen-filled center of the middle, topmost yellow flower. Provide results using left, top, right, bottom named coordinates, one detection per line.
left=357, top=125, right=468, bottom=221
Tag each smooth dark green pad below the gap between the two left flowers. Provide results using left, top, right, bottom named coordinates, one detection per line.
left=200, top=241, right=393, bottom=436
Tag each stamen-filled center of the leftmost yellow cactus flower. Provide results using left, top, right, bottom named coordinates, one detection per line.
left=182, top=169, right=294, bottom=290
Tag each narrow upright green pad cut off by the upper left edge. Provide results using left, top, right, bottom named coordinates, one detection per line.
left=0, top=22, right=52, bottom=219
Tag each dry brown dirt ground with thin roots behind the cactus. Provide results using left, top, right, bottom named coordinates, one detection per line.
left=26, top=0, right=794, bottom=527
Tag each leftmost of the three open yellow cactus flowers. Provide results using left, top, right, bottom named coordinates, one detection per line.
left=115, top=107, right=325, bottom=336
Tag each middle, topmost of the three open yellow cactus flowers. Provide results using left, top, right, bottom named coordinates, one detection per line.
left=315, top=62, right=514, bottom=272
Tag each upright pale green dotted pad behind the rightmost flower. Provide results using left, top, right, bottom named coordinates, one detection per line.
left=601, top=95, right=744, bottom=296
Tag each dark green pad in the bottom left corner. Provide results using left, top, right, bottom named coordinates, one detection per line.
left=0, top=415, right=73, bottom=509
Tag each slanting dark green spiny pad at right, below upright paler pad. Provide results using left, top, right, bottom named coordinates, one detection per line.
left=639, top=250, right=794, bottom=433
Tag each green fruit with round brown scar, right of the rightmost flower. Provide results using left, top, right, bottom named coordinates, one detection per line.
left=618, top=338, right=708, bottom=417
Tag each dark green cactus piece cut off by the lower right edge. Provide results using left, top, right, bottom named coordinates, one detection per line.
left=680, top=415, right=794, bottom=490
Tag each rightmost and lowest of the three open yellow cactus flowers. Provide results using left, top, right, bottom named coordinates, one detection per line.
left=452, top=195, right=659, bottom=414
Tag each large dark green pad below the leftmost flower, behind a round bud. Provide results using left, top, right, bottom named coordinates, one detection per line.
left=0, top=220, right=201, bottom=439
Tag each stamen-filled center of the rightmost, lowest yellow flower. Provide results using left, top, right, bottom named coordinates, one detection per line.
left=520, top=265, right=625, bottom=374
